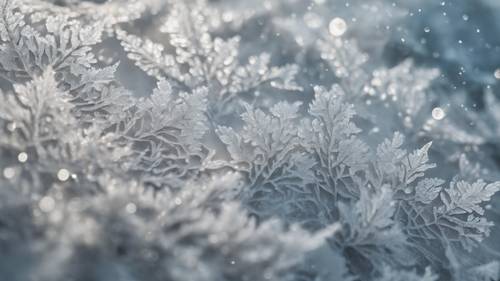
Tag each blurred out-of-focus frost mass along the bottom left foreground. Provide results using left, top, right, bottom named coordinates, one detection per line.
left=0, top=166, right=331, bottom=281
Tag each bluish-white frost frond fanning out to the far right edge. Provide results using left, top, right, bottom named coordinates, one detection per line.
left=397, top=176, right=500, bottom=263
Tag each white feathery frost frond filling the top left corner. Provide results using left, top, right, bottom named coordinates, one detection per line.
left=0, top=0, right=130, bottom=130
